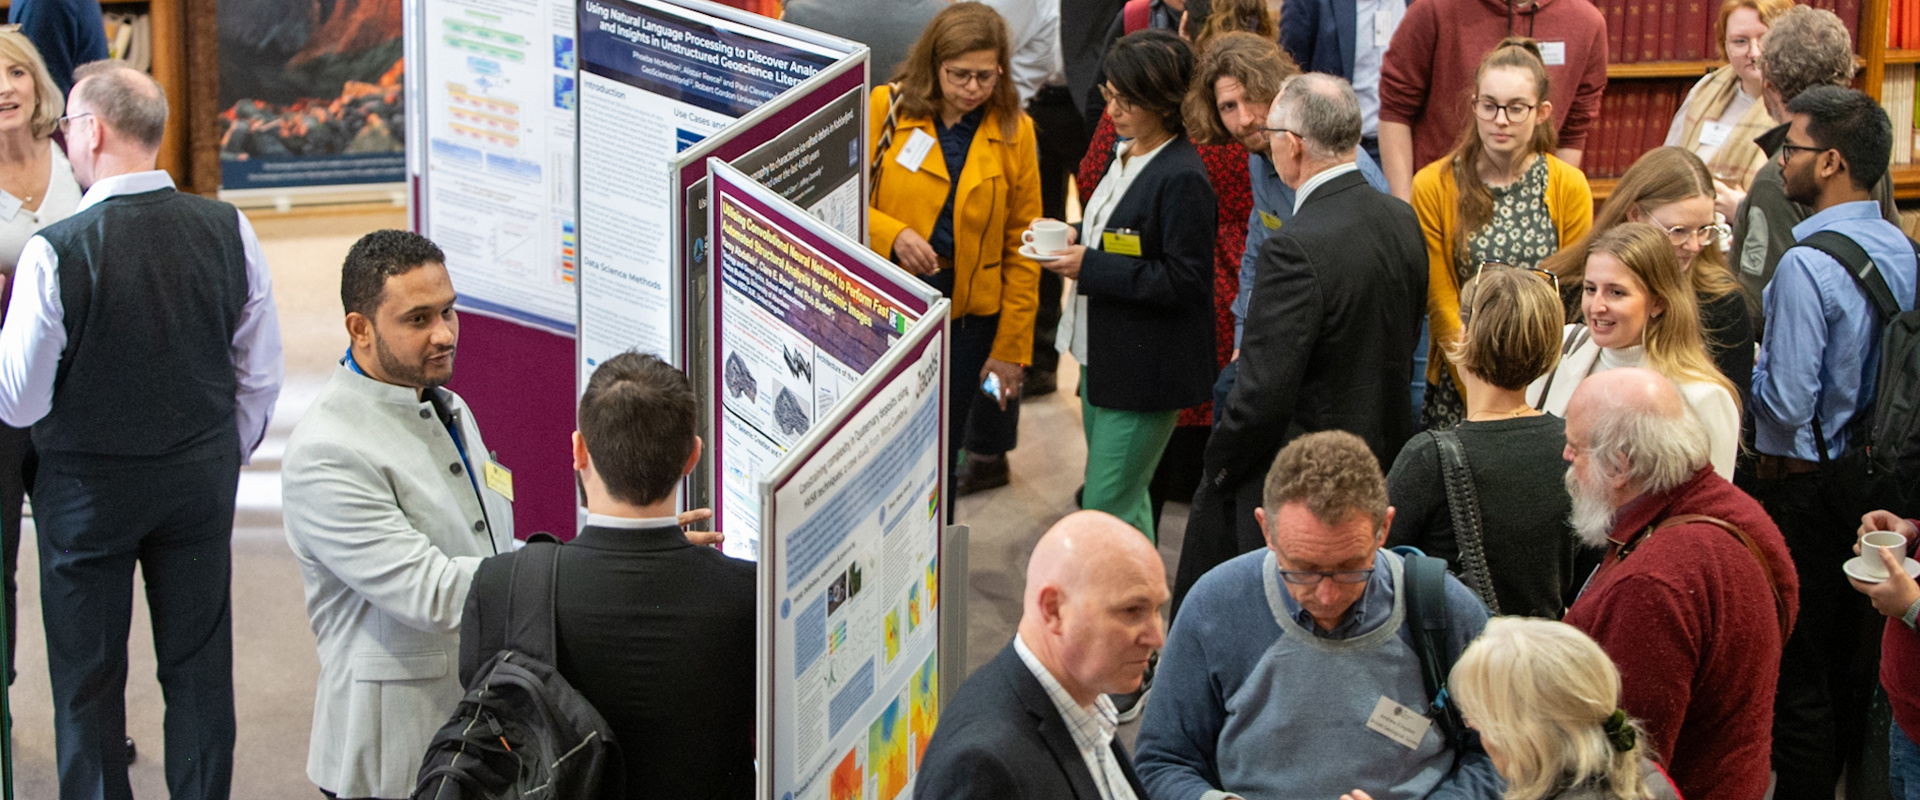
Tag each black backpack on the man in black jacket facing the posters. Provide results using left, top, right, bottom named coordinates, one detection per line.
left=413, top=541, right=626, bottom=800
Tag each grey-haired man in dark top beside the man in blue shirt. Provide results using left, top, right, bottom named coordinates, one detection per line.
left=1716, top=6, right=1901, bottom=305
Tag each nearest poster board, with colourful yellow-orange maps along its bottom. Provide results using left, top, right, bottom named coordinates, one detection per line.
left=760, top=295, right=948, bottom=800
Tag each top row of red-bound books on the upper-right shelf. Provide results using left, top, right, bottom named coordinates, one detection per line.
left=1596, top=0, right=1858, bottom=63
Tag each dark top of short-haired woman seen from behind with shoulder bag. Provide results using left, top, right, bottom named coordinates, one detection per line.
left=1386, top=414, right=1597, bottom=620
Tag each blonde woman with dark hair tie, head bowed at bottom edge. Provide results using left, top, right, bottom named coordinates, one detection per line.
left=1448, top=616, right=1680, bottom=800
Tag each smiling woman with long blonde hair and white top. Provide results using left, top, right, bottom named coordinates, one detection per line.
left=1526, top=223, right=1740, bottom=480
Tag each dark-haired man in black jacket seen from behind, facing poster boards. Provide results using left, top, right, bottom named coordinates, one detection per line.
left=461, top=353, right=755, bottom=800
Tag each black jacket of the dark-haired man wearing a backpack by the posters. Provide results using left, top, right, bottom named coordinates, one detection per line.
left=461, top=526, right=755, bottom=800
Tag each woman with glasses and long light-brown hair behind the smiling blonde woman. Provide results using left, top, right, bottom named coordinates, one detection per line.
left=1542, top=148, right=1755, bottom=407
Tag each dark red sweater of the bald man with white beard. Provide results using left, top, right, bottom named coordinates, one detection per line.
left=1567, top=468, right=1799, bottom=800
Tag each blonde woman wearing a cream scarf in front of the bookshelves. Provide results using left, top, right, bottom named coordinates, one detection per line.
left=1667, top=0, right=1793, bottom=219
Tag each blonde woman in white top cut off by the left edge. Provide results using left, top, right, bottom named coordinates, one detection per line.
left=0, top=25, right=81, bottom=683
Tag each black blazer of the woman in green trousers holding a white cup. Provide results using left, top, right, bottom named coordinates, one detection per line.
left=1075, top=136, right=1213, bottom=411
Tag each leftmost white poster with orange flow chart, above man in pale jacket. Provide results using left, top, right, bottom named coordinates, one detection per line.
left=407, top=0, right=580, bottom=336
